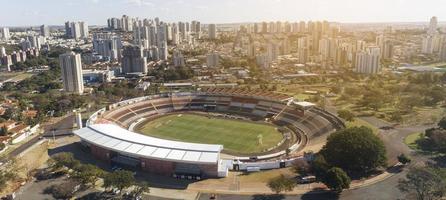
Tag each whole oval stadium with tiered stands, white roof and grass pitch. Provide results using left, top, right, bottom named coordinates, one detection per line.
left=74, top=88, right=345, bottom=179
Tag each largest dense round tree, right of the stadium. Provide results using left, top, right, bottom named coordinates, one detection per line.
left=320, top=126, right=387, bottom=175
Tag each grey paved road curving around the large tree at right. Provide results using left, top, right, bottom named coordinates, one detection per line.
left=199, top=117, right=432, bottom=200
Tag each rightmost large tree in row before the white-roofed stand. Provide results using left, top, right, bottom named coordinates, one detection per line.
left=104, top=170, right=135, bottom=192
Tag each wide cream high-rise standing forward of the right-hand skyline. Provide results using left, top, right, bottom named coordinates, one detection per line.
left=355, top=47, right=381, bottom=74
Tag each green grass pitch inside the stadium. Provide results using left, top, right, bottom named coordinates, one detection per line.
left=137, top=114, right=283, bottom=154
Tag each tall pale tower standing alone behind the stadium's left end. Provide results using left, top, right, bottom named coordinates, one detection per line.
left=59, top=52, right=84, bottom=94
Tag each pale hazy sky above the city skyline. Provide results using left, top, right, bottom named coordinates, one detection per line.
left=0, top=0, right=446, bottom=27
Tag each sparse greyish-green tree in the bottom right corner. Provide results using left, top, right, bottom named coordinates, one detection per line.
left=398, top=167, right=446, bottom=200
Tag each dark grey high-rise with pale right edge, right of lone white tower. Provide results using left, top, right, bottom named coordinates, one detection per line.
left=121, top=45, right=147, bottom=74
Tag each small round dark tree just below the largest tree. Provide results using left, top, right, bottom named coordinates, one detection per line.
left=321, top=167, right=351, bottom=193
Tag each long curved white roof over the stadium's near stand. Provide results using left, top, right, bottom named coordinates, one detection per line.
left=74, top=124, right=223, bottom=164
